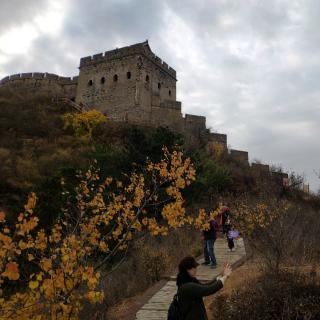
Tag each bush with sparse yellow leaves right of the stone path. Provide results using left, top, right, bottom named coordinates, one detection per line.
left=233, top=198, right=294, bottom=272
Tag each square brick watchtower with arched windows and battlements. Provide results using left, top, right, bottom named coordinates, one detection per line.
left=76, top=42, right=182, bottom=128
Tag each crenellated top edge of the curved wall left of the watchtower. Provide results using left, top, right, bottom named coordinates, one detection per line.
left=0, top=72, right=78, bottom=85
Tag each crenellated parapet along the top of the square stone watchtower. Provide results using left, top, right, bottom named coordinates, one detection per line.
left=80, top=40, right=177, bottom=79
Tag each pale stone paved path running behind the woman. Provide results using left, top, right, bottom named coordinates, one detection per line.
left=136, top=238, right=246, bottom=320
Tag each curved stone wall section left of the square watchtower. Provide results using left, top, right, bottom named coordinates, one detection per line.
left=0, top=72, right=78, bottom=99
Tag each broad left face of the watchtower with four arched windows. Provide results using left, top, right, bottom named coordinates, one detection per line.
left=76, top=50, right=139, bottom=121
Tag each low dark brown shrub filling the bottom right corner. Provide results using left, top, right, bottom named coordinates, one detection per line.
left=213, top=271, right=320, bottom=320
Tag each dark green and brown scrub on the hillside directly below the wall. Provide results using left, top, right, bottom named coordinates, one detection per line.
left=0, top=90, right=318, bottom=230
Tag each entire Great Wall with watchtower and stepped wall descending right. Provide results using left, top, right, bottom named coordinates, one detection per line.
left=0, top=41, right=288, bottom=183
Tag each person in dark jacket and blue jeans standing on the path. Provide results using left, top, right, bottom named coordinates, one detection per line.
left=202, top=215, right=218, bottom=268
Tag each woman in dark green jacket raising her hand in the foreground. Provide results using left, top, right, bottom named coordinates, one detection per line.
left=177, top=257, right=232, bottom=320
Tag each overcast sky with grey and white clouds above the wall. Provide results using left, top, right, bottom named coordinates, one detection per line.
left=0, top=0, right=320, bottom=191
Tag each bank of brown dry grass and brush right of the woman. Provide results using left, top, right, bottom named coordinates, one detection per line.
left=206, top=261, right=320, bottom=320
